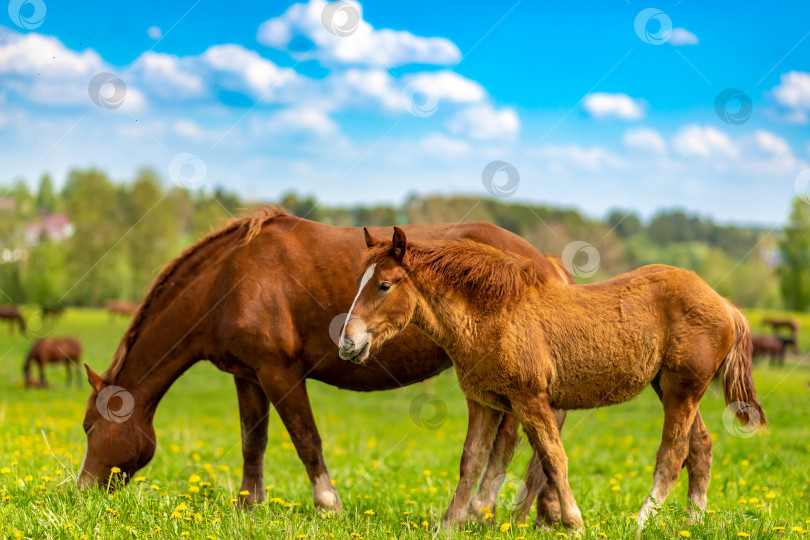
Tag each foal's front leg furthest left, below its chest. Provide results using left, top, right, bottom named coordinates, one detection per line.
left=443, top=398, right=503, bottom=528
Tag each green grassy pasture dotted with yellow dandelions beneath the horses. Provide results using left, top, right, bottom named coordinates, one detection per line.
left=0, top=309, right=810, bottom=539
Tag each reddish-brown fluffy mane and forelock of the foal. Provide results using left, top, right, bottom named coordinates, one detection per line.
left=364, top=239, right=545, bottom=307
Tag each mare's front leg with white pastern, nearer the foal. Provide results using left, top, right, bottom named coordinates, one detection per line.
left=259, top=366, right=343, bottom=512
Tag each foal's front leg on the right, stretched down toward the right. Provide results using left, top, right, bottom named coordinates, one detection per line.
left=512, top=394, right=584, bottom=529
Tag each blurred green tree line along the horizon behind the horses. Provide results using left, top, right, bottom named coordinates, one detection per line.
left=0, top=169, right=810, bottom=311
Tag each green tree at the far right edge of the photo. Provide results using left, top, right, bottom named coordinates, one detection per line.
left=777, top=198, right=810, bottom=311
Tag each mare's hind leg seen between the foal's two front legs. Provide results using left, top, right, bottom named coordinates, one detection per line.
left=470, top=414, right=520, bottom=519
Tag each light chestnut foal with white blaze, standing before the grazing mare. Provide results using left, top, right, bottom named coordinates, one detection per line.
left=340, top=227, right=764, bottom=527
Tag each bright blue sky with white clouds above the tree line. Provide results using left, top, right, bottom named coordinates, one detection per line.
left=0, top=0, right=810, bottom=224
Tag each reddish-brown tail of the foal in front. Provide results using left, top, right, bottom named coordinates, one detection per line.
left=723, top=302, right=766, bottom=428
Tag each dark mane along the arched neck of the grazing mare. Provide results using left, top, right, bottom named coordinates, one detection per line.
left=104, top=205, right=287, bottom=380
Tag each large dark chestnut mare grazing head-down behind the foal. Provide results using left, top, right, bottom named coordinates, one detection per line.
left=79, top=210, right=571, bottom=517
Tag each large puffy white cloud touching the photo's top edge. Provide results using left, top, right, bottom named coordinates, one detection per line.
left=256, top=0, right=461, bottom=68
